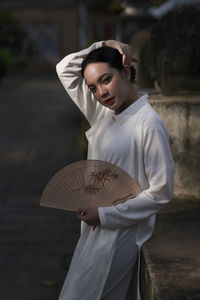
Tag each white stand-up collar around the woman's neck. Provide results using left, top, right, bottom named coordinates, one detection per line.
left=111, top=93, right=148, bottom=123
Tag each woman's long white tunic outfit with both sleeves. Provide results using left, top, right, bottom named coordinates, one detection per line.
left=57, top=42, right=174, bottom=300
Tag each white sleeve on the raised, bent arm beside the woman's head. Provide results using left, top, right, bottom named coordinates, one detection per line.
left=56, top=42, right=108, bottom=126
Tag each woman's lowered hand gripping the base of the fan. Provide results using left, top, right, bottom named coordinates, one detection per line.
left=76, top=207, right=101, bottom=227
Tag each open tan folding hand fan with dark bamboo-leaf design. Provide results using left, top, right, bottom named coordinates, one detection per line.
left=40, top=160, right=141, bottom=211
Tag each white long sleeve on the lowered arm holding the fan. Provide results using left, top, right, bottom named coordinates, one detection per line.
left=99, top=120, right=174, bottom=229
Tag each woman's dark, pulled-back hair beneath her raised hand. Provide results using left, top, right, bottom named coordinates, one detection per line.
left=81, top=46, right=136, bottom=83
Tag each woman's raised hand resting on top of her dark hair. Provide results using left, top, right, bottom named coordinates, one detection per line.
left=103, top=40, right=137, bottom=66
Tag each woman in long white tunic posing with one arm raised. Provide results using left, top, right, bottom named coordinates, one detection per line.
left=57, top=40, right=174, bottom=300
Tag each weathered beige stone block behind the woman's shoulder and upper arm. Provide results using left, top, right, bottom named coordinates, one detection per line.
left=150, top=95, right=200, bottom=198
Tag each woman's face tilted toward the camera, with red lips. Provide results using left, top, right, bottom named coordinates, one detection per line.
left=84, top=62, right=131, bottom=113
